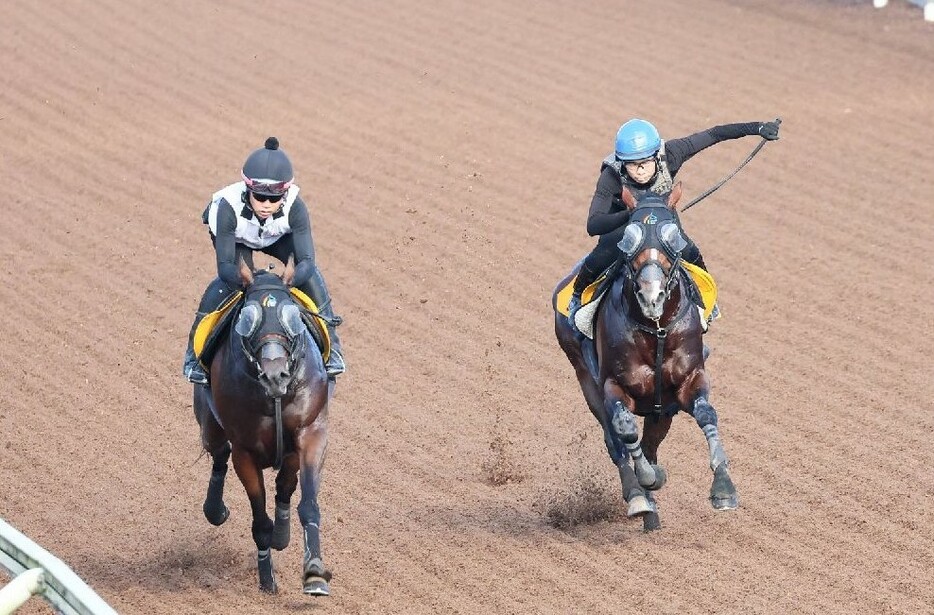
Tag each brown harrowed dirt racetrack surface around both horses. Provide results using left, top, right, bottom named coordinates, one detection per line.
left=0, top=0, right=934, bottom=615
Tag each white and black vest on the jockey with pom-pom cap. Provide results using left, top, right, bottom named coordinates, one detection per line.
left=207, top=181, right=299, bottom=250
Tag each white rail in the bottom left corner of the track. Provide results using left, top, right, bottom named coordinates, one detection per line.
left=0, top=519, right=117, bottom=615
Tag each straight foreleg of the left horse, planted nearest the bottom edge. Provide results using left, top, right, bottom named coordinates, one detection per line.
left=296, top=409, right=331, bottom=596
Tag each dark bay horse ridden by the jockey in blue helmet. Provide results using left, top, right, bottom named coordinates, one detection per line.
left=552, top=183, right=739, bottom=530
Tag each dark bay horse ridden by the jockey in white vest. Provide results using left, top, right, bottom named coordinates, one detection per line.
left=194, top=260, right=333, bottom=596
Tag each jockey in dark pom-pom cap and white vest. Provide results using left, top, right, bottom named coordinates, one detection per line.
left=182, top=137, right=345, bottom=384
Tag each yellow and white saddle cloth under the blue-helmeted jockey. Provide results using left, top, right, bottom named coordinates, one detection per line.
left=557, top=261, right=717, bottom=339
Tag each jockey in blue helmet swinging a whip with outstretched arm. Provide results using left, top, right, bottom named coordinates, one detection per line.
left=568, top=119, right=779, bottom=330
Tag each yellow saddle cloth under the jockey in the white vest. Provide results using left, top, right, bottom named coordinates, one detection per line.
left=193, top=288, right=331, bottom=370
